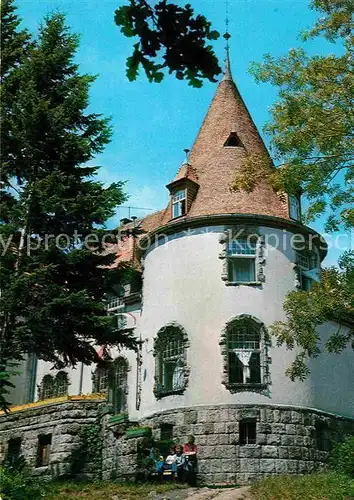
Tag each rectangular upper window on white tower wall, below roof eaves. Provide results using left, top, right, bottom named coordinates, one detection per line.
left=227, top=238, right=257, bottom=283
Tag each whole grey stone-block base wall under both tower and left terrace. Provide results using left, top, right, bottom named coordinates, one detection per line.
left=0, top=401, right=354, bottom=484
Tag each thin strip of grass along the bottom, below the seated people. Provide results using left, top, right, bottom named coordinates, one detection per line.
left=45, top=482, right=189, bottom=500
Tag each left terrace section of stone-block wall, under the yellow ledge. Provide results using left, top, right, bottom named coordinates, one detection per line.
left=0, top=400, right=102, bottom=476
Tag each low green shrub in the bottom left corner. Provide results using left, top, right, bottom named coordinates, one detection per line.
left=0, top=465, right=45, bottom=500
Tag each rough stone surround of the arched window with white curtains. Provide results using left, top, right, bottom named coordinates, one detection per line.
left=219, top=314, right=272, bottom=397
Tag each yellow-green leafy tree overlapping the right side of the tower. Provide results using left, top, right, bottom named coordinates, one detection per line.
left=235, top=0, right=354, bottom=379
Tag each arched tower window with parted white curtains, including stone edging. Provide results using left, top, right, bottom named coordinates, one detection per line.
left=220, top=315, right=269, bottom=391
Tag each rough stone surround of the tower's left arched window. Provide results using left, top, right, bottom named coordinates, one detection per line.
left=153, top=321, right=190, bottom=399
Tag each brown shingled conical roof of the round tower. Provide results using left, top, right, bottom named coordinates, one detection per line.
left=166, top=54, right=289, bottom=218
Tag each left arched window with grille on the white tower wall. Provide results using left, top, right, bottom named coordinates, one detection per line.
left=154, top=325, right=189, bottom=397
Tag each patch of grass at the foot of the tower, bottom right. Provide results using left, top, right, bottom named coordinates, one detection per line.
left=250, top=472, right=354, bottom=500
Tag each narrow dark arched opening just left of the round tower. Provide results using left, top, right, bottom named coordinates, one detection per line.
left=108, top=357, right=129, bottom=413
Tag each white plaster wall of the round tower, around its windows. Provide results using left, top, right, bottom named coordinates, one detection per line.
left=140, top=227, right=353, bottom=417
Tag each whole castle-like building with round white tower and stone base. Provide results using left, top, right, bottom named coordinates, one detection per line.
left=0, top=51, right=354, bottom=483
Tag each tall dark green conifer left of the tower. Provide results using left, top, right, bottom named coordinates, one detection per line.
left=0, top=8, right=134, bottom=408
